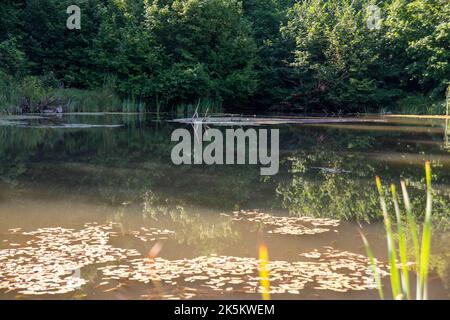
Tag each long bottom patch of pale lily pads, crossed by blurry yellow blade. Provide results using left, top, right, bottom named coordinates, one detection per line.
left=100, top=247, right=384, bottom=296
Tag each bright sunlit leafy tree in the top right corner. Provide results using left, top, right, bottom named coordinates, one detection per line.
left=384, top=0, right=450, bottom=97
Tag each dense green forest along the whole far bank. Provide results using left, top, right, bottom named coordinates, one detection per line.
left=0, top=0, right=450, bottom=113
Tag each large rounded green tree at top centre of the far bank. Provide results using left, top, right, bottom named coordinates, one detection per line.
left=146, top=0, right=256, bottom=103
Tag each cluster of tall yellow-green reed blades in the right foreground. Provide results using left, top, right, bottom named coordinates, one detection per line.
left=361, top=161, right=432, bottom=300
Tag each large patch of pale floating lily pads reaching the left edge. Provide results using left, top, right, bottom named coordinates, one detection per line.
left=0, top=223, right=171, bottom=295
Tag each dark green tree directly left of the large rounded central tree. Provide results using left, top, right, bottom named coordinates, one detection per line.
left=89, top=0, right=162, bottom=98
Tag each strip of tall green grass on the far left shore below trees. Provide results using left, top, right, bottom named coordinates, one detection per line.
left=0, top=74, right=222, bottom=116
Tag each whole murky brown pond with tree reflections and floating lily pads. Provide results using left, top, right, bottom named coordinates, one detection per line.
left=0, top=113, right=450, bottom=299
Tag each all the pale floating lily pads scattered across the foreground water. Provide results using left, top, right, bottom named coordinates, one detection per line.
left=0, top=211, right=386, bottom=299
